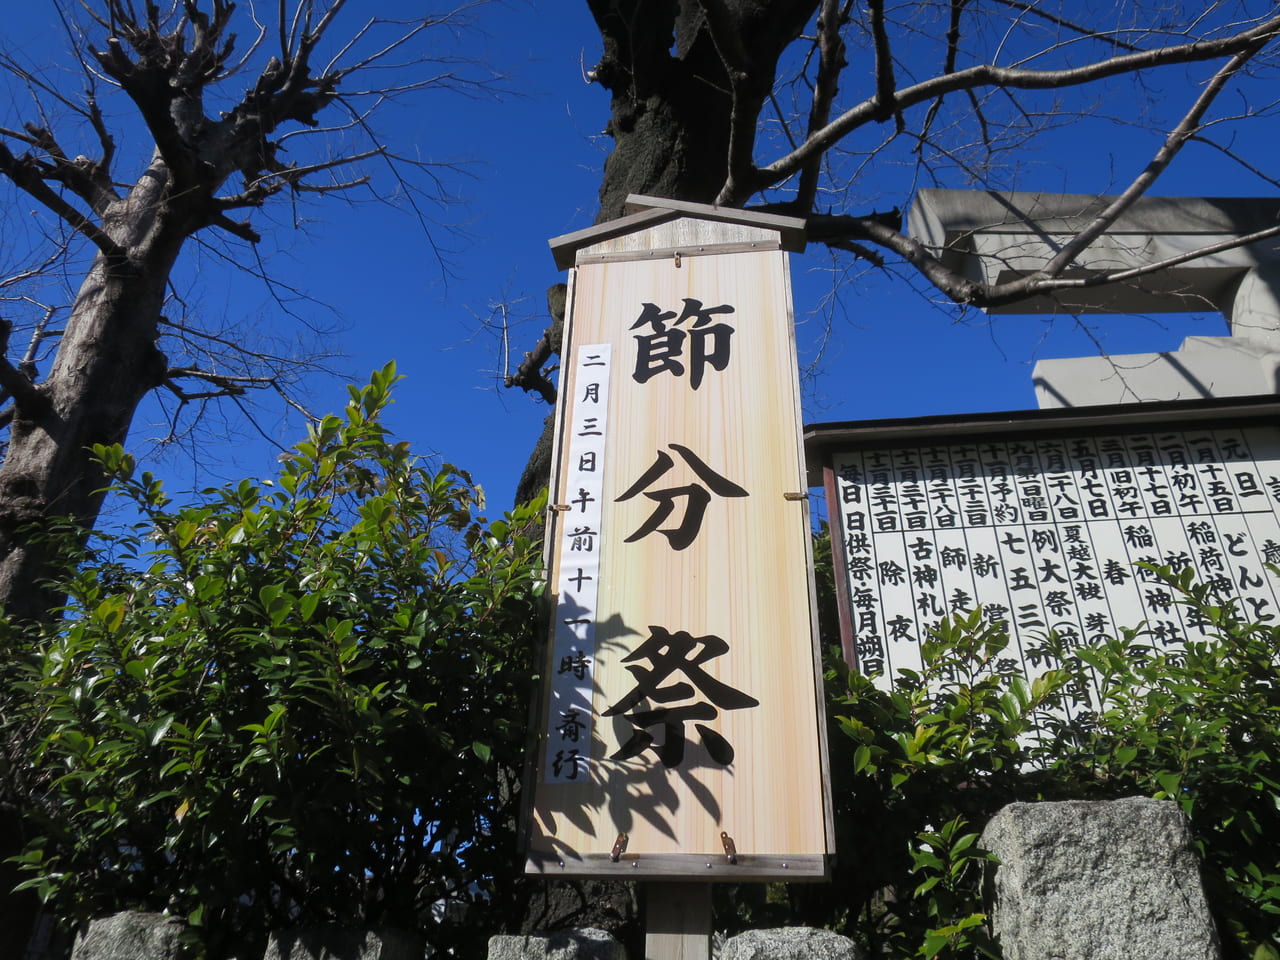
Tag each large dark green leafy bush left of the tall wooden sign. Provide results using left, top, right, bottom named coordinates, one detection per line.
left=15, top=367, right=541, bottom=955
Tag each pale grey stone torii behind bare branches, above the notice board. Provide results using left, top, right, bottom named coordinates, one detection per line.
left=909, top=189, right=1280, bottom=408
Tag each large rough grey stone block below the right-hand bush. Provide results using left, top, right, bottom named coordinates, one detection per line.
left=980, top=797, right=1220, bottom=960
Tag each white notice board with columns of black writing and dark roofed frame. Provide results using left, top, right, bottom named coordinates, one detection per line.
left=805, top=394, right=1280, bottom=682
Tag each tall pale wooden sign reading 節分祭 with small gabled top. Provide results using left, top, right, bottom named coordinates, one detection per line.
left=525, top=197, right=832, bottom=881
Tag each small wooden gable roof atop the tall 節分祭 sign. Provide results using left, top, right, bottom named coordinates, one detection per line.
left=549, top=193, right=805, bottom=270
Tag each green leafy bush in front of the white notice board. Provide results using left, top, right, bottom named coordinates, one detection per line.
left=721, top=538, right=1280, bottom=960
